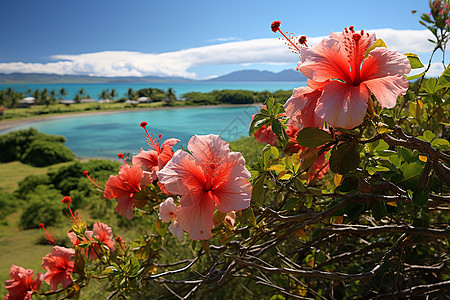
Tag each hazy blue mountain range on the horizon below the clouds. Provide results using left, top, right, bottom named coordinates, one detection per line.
left=0, top=70, right=306, bottom=84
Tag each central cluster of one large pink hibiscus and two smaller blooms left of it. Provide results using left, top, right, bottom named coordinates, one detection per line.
left=103, top=122, right=252, bottom=240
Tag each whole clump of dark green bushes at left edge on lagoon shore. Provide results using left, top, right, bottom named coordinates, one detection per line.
left=0, top=128, right=74, bottom=167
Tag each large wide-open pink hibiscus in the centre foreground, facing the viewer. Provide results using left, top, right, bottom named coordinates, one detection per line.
left=157, top=134, right=252, bottom=240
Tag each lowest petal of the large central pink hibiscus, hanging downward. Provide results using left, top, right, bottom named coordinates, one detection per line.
left=177, top=189, right=215, bottom=240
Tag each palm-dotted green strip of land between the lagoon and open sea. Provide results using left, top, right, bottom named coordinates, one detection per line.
left=0, top=88, right=292, bottom=120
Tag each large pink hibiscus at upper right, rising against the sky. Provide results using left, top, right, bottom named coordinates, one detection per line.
left=285, top=27, right=411, bottom=129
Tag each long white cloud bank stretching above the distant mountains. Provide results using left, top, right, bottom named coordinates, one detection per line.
left=0, top=28, right=442, bottom=78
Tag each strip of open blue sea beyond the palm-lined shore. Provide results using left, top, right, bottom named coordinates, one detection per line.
left=0, top=81, right=306, bottom=99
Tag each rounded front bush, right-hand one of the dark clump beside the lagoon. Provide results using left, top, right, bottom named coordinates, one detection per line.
left=21, top=140, right=75, bottom=167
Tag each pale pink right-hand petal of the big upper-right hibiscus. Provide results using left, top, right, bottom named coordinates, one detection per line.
left=363, top=75, right=409, bottom=108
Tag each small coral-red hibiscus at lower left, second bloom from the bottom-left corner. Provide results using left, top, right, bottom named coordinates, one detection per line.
left=42, top=246, right=75, bottom=291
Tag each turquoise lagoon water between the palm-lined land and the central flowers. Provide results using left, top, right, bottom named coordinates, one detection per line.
left=4, top=106, right=258, bottom=159
